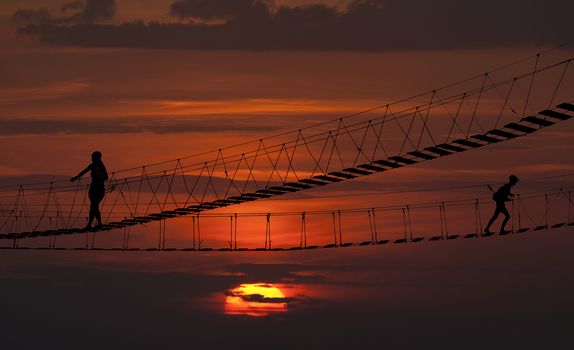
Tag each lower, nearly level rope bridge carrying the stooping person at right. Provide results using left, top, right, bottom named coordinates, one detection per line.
left=0, top=186, right=574, bottom=252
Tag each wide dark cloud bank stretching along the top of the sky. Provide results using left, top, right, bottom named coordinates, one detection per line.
left=15, top=0, right=574, bottom=52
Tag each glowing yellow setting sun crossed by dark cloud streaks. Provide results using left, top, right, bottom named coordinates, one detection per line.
left=225, top=283, right=287, bottom=317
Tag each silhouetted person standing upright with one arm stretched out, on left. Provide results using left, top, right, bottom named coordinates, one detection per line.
left=70, top=151, right=108, bottom=228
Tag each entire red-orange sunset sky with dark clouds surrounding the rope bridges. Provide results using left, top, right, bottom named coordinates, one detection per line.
left=0, top=0, right=574, bottom=349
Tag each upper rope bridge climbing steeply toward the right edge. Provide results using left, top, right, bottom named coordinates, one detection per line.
left=0, top=51, right=574, bottom=248
